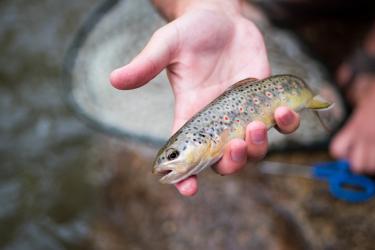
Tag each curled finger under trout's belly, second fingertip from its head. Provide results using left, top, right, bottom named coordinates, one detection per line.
left=213, top=139, right=247, bottom=175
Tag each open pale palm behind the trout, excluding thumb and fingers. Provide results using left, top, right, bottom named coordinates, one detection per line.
left=162, top=10, right=269, bottom=130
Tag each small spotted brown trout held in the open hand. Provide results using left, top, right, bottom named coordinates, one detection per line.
left=153, top=75, right=331, bottom=184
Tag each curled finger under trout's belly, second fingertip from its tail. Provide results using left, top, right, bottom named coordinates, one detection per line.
left=246, top=121, right=268, bottom=161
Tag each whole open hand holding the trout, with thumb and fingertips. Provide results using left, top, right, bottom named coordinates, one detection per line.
left=110, top=0, right=299, bottom=196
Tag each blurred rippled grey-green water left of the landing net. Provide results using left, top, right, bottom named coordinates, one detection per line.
left=0, top=0, right=103, bottom=249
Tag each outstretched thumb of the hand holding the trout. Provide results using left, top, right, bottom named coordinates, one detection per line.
left=110, top=25, right=177, bottom=89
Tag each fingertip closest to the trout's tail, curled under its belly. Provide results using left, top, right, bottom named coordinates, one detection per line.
left=274, top=107, right=300, bottom=134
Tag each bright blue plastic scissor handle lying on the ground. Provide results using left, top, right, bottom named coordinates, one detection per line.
left=313, top=160, right=375, bottom=203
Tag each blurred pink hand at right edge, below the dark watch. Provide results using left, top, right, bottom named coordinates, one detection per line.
left=330, top=71, right=375, bottom=174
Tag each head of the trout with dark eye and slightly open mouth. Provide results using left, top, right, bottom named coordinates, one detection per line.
left=152, top=134, right=217, bottom=184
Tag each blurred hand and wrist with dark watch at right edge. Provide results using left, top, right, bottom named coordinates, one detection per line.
left=330, top=24, right=375, bottom=174
